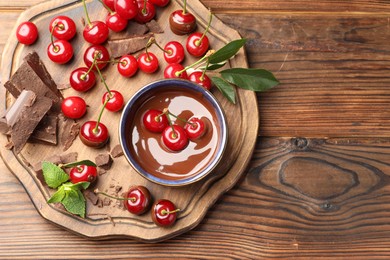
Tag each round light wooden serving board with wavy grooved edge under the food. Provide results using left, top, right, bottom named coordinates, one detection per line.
left=0, top=0, right=259, bottom=242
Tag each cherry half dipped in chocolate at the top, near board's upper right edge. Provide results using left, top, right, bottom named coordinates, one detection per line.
left=169, top=10, right=196, bottom=35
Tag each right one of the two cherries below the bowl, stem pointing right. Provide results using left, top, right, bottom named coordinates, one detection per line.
left=151, top=199, right=180, bottom=227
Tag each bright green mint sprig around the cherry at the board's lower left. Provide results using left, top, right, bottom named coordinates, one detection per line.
left=42, top=160, right=95, bottom=218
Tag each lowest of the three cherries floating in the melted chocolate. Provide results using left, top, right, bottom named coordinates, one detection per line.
left=162, top=125, right=188, bottom=152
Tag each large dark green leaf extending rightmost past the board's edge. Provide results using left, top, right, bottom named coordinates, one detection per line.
left=220, top=68, right=279, bottom=92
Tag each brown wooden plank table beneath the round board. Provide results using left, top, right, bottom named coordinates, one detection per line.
left=0, top=0, right=390, bottom=259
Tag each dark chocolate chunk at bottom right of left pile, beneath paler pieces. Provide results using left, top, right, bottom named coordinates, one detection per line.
left=29, top=115, right=58, bottom=145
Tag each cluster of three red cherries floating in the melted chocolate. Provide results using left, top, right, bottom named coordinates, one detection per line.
left=142, top=109, right=206, bottom=152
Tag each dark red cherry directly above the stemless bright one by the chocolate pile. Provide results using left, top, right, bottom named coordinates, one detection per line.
left=69, top=67, right=96, bottom=92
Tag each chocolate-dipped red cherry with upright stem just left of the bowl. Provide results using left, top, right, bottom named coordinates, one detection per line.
left=79, top=121, right=110, bottom=148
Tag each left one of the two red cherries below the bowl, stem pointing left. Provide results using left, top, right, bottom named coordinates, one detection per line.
left=124, top=186, right=152, bottom=215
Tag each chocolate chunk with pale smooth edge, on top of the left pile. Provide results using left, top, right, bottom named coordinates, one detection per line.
left=6, top=90, right=53, bottom=153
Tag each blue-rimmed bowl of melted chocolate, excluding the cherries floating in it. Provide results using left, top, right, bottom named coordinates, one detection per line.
left=119, top=79, right=227, bottom=186
